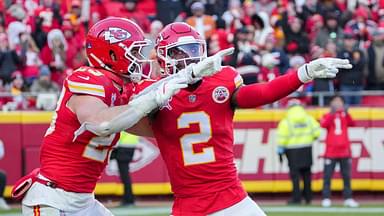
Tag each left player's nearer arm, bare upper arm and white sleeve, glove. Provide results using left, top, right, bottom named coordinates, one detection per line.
left=68, top=78, right=187, bottom=138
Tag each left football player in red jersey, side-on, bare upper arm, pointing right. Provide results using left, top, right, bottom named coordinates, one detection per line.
left=12, top=17, right=230, bottom=216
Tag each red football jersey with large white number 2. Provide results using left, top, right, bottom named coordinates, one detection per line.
left=152, top=67, right=246, bottom=215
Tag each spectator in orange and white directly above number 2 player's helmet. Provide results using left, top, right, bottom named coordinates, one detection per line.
left=185, top=2, right=216, bottom=40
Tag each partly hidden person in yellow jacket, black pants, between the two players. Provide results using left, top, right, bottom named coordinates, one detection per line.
left=111, top=131, right=139, bottom=206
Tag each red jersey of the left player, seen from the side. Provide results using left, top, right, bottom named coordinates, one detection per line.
left=40, top=67, right=122, bottom=193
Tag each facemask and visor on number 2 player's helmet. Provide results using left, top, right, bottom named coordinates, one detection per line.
left=158, top=40, right=207, bottom=76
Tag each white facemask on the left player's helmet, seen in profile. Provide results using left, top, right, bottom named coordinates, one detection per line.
left=119, top=39, right=153, bottom=82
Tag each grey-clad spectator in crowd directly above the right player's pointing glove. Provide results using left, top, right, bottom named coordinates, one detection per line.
left=314, top=12, right=343, bottom=50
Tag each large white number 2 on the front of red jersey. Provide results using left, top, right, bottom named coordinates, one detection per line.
left=177, top=111, right=216, bottom=166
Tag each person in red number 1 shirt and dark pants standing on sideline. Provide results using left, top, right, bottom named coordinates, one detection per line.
left=321, top=96, right=359, bottom=207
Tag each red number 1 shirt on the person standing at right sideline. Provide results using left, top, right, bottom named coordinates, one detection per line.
left=321, top=110, right=355, bottom=158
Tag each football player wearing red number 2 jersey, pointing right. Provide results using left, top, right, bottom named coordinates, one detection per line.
left=132, top=23, right=351, bottom=216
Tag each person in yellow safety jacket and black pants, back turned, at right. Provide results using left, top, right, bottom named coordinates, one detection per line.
left=277, top=101, right=320, bottom=204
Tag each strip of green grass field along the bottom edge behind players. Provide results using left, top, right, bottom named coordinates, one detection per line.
left=0, top=203, right=384, bottom=216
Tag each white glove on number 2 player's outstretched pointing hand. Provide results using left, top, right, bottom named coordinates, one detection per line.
left=297, top=58, right=352, bottom=83
